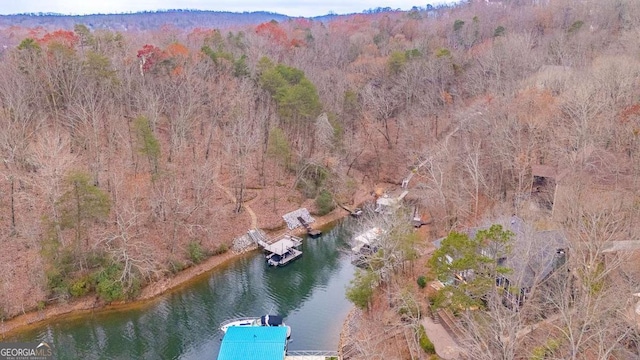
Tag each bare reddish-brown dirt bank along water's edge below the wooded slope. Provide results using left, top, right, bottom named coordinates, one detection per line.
left=0, top=207, right=349, bottom=340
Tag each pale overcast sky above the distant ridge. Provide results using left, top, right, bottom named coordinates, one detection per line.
left=0, top=0, right=460, bottom=17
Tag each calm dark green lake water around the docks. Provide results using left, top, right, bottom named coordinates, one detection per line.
left=13, top=223, right=354, bottom=359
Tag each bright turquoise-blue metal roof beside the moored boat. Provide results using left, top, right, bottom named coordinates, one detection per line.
left=218, top=326, right=287, bottom=360
